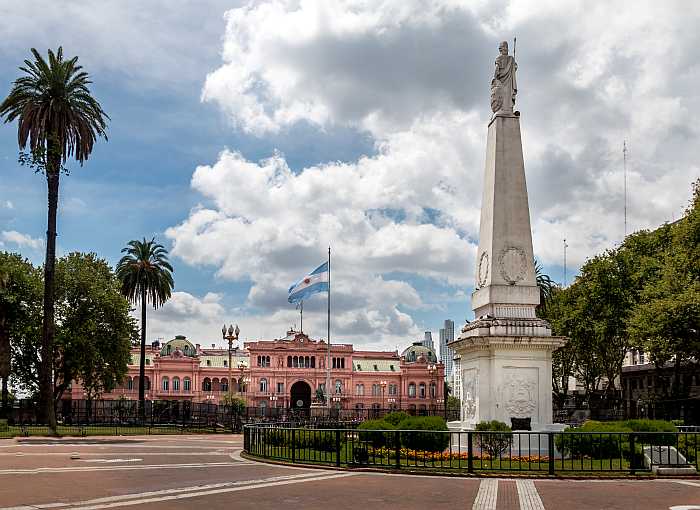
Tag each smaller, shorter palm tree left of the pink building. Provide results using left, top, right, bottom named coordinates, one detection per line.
left=116, top=238, right=173, bottom=419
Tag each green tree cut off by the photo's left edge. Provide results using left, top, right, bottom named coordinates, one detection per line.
left=0, top=252, right=41, bottom=417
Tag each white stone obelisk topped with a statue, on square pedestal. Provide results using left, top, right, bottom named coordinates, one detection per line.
left=450, top=42, right=566, bottom=430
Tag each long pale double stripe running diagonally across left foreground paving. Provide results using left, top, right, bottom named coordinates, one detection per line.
left=0, top=472, right=355, bottom=510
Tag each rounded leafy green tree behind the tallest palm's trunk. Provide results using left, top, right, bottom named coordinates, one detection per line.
left=12, top=253, right=137, bottom=402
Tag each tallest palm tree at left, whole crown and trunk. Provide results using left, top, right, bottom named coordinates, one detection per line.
left=0, top=47, right=109, bottom=431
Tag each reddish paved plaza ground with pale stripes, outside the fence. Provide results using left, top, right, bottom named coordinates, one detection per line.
left=0, top=434, right=700, bottom=510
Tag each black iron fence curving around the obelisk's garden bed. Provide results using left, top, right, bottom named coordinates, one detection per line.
left=244, top=424, right=700, bottom=475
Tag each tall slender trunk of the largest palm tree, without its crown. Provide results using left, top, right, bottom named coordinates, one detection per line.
left=39, top=168, right=60, bottom=434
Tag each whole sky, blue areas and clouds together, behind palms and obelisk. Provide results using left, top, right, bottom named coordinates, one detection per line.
left=0, top=0, right=700, bottom=348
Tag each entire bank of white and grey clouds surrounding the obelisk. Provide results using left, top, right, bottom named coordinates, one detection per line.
left=167, top=0, right=700, bottom=345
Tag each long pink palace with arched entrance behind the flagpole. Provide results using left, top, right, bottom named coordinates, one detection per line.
left=79, top=331, right=445, bottom=410
